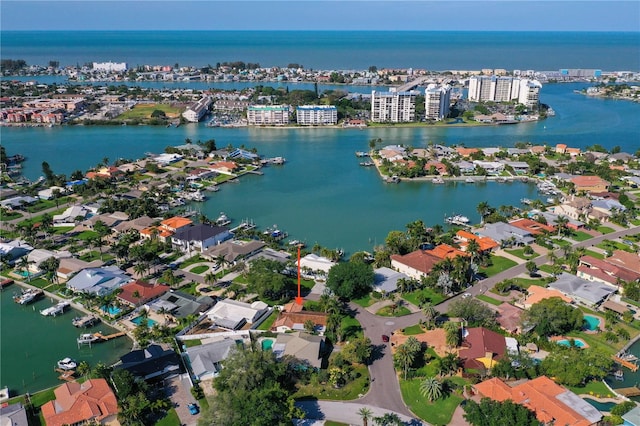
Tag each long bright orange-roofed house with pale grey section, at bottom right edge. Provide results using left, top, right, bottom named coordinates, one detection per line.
left=473, top=376, right=602, bottom=426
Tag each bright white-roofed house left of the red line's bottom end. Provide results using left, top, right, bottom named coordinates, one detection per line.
left=206, top=299, right=270, bottom=330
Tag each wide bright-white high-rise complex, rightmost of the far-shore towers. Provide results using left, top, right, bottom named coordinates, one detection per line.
left=469, top=76, right=542, bottom=108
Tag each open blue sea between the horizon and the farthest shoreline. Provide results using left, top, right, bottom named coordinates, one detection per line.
left=1, top=30, right=640, bottom=71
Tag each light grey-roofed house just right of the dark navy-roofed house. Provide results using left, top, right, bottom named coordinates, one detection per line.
left=186, top=338, right=241, bottom=381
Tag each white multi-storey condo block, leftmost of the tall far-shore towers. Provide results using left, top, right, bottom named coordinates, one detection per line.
left=371, top=90, right=420, bottom=123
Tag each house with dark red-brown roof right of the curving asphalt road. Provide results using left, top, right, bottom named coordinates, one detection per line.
left=458, top=327, right=507, bottom=370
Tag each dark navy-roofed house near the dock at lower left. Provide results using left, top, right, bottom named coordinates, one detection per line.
left=115, top=344, right=182, bottom=380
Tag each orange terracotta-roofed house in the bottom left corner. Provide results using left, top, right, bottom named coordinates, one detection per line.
left=42, top=379, right=118, bottom=426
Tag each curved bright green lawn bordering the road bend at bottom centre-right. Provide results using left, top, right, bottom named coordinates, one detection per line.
left=400, top=379, right=463, bottom=426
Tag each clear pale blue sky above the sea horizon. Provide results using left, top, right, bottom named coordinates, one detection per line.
left=0, top=0, right=640, bottom=32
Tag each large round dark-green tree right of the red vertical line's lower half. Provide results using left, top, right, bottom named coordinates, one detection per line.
left=327, top=262, right=374, bottom=300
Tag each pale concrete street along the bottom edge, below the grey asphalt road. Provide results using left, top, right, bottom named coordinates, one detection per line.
left=296, top=401, right=425, bottom=426
